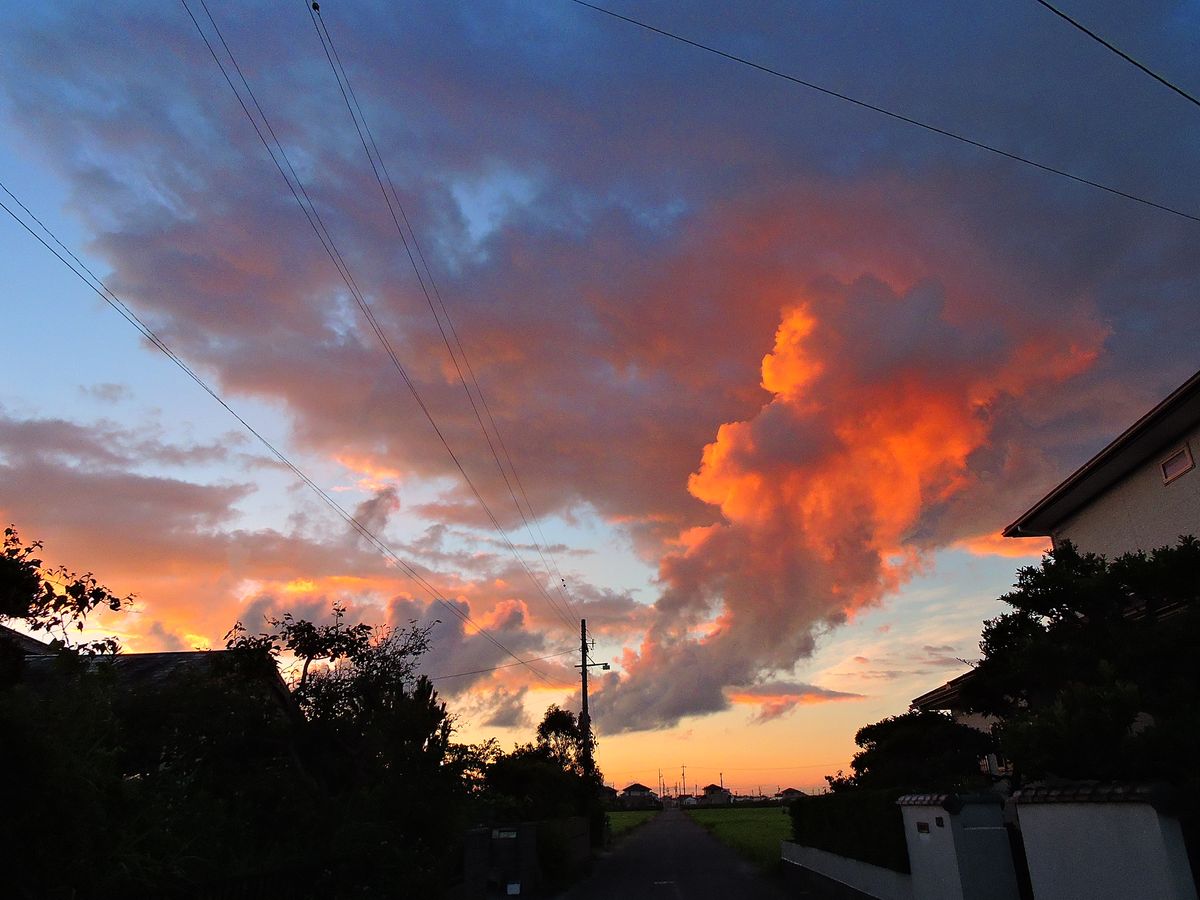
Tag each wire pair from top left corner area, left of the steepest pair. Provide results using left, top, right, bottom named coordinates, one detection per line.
left=180, top=0, right=574, bottom=628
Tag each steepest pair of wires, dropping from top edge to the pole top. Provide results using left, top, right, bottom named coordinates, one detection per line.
left=304, top=0, right=577, bottom=628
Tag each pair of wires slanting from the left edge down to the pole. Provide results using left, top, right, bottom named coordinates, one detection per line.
left=0, top=181, right=571, bottom=688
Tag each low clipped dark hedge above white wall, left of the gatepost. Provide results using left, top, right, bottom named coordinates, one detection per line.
left=790, top=790, right=908, bottom=872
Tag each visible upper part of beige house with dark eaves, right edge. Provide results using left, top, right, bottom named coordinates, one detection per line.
left=1003, top=372, right=1200, bottom=558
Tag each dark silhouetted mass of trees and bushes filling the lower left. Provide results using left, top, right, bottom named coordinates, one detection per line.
left=0, top=528, right=602, bottom=900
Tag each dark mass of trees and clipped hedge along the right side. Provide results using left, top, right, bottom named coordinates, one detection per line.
left=806, top=536, right=1200, bottom=870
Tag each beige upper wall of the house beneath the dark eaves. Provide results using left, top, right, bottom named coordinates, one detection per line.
left=1054, top=427, right=1200, bottom=558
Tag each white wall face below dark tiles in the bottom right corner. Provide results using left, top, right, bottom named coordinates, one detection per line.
left=1018, top=803, right=1196, bottom=900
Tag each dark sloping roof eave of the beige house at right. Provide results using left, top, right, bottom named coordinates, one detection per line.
left=1003, top=372, right=1200, bottom=538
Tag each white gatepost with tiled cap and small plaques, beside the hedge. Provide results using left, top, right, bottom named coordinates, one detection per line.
left=896, top=793, right=1020, bottom=900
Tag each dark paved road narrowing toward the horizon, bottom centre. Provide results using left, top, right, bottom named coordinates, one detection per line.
left=559, top=809, right=786, bottom=900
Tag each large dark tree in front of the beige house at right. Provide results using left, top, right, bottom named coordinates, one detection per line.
left=964, top=536, right=1200, bottom=782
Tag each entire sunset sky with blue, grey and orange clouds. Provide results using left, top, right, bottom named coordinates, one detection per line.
left=0, top=0, right=1200, bottom=793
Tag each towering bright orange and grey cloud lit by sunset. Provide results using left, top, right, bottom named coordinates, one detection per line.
left=596, top=277, right=1104, bottom=728
